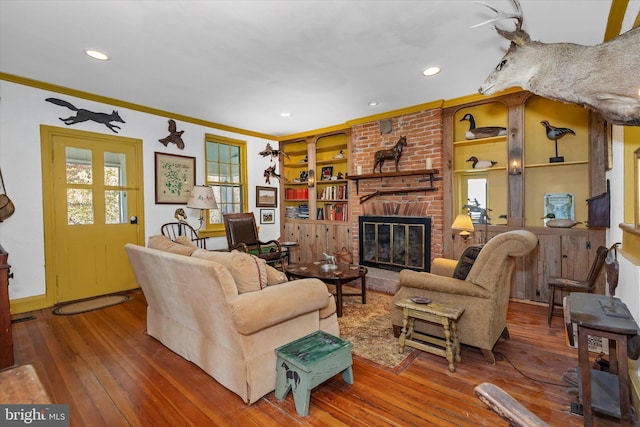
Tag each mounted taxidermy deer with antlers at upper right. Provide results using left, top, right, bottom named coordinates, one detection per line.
left=472, top=0, right=640, bottom=126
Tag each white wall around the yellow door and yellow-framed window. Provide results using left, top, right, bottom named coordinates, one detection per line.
left=0, top=80, right=280, bottom=299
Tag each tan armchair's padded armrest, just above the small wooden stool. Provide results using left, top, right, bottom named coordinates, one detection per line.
left=400, top=270, right=491, bottom=298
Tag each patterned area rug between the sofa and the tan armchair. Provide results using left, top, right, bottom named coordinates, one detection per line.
left=338, top=286, right=420, bottom=372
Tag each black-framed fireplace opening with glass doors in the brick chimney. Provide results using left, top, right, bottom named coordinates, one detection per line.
left=358, top=215, right=431, bottom=271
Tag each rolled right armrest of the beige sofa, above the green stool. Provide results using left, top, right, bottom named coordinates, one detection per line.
left=230, top=279, right=329, bottom=335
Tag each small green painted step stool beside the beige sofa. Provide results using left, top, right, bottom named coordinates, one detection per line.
left=275, top=331, right=353, bottom=417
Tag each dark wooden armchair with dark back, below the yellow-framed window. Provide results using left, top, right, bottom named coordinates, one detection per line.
left=222, top=212, right=284, bottom=266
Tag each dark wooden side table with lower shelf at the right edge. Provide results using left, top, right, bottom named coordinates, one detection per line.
left=567, top=293, right=639, bottom=426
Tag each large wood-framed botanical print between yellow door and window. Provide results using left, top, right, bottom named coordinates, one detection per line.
left=155, top=152, right=196, bottom=205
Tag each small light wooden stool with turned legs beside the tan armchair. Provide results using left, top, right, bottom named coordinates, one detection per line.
left=396, top=299, right=464, bottom=372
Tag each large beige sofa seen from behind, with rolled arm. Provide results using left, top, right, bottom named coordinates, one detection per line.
left=125, top=236, right=339, bottom=404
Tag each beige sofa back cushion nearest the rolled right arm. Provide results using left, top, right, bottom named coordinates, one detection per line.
left=191, top=249, right=267, bottom=294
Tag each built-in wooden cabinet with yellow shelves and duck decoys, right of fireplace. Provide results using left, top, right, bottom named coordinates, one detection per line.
left=443, top=92, right=607, bottom=302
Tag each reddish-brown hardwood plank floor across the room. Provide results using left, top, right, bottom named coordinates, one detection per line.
left=6, top=291, right=618, bottom=427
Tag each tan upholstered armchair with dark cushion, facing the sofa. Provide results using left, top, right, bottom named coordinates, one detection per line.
left=391, top=230, right=537, bottom=364
